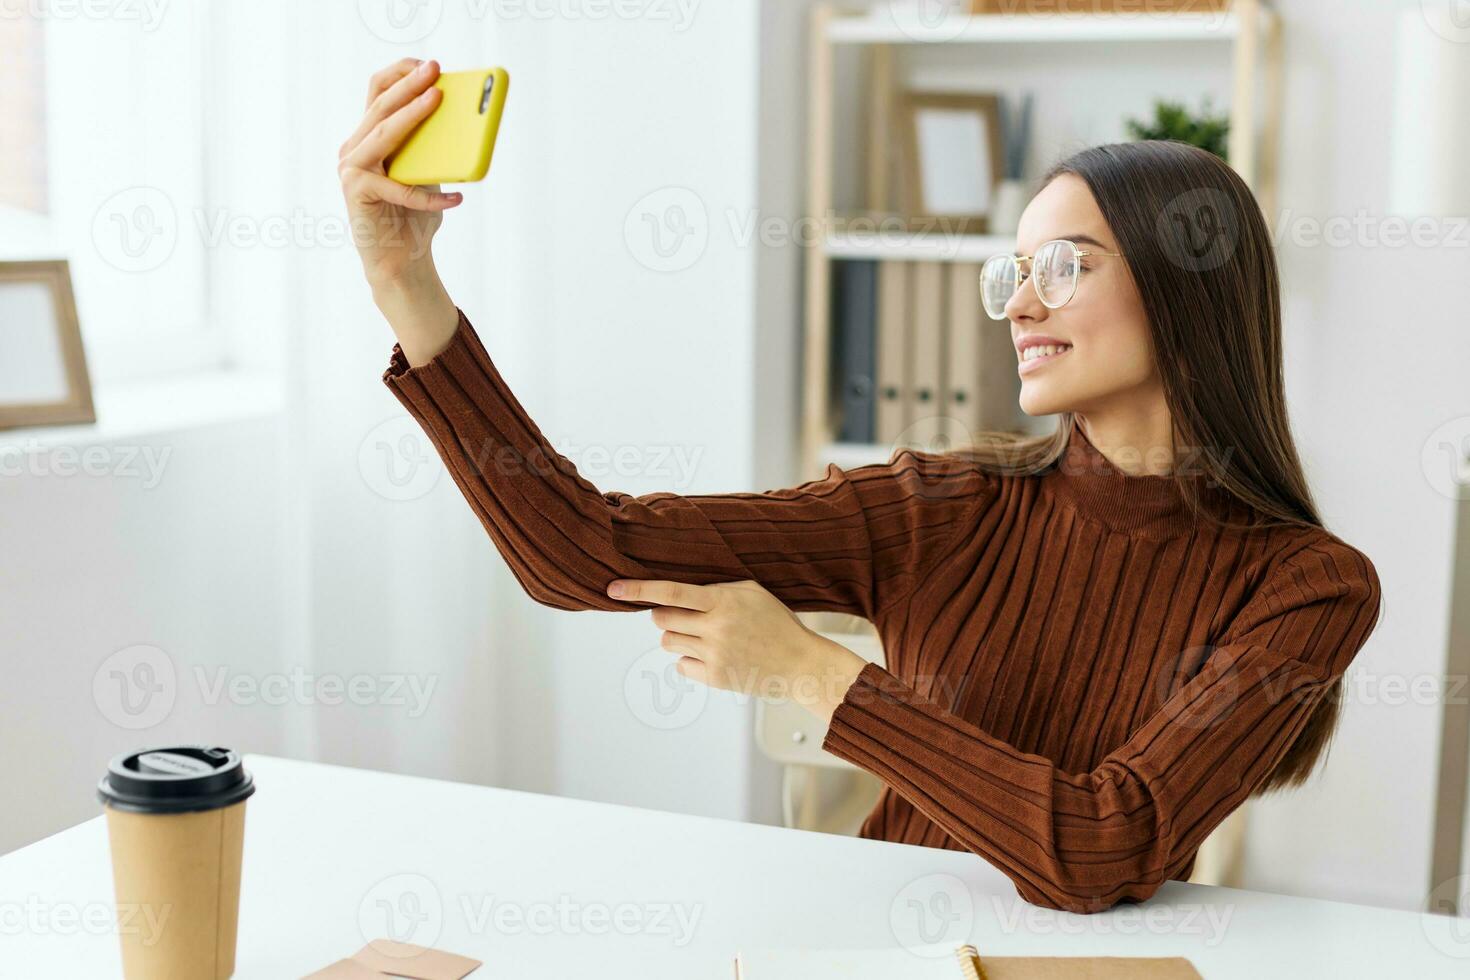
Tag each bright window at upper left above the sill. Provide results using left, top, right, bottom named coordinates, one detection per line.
left=0, top=3, right=223, bottom=383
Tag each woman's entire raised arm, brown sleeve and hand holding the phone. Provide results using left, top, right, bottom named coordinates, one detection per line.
left=338, top=59, right=994, bottom=619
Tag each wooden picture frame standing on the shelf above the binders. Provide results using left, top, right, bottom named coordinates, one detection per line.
left=900, top=93, right=1005, bottom=234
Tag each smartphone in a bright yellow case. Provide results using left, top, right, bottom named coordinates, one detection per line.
left=388, top=68, right=510, bottom=184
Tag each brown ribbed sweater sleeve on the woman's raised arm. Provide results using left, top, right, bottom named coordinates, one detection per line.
left=384, top=311, right=994, bottom=619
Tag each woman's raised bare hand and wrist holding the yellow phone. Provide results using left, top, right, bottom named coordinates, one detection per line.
left=337, top=57, right=465, bottom=366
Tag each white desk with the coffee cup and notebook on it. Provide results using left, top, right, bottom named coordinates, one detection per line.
left=0, top=757, right=1470, bottom=980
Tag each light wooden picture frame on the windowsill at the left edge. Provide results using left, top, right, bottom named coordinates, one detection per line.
left=0, top=259, right=97, bottom=429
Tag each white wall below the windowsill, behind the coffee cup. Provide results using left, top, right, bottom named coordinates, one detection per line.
left=0, top=403, right=297, bottom=852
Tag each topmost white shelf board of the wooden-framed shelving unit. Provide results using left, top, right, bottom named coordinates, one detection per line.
left=826, top=9, right=1241, bottom=44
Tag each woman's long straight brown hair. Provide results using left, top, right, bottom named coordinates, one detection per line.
left=963, top=140, right=1342, bottom=795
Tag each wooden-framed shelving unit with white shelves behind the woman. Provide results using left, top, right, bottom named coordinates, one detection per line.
left=801, top=0, right=1280, bottom=478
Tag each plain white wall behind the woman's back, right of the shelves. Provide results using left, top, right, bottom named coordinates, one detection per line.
left=1248, top=0, right=1470, bottom=908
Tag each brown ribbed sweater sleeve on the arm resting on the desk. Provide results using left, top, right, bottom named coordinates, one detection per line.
left=823, top=539, right=1380, bottom=912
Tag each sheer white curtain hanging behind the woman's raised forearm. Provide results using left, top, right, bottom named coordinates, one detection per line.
left=258, top=3, right=551, bottom=783
